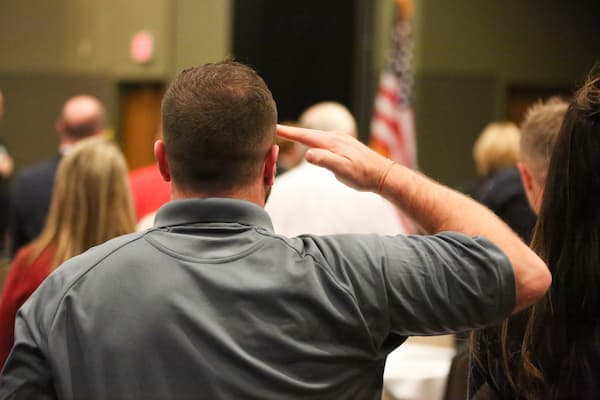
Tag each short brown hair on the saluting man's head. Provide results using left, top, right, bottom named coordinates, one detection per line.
left=162, top=61, right=277, bottom=192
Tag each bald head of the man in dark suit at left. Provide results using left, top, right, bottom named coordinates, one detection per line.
left=57, top=95, right=106, bottom=142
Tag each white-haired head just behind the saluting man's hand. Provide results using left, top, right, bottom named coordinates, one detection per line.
left=298, top=101, right=357, bottom=137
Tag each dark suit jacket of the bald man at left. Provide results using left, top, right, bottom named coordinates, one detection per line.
left=9, top=155, right=61, bottom=256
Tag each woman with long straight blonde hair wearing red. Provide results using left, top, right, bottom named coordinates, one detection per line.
left=0, top=137, right=135, bottom=366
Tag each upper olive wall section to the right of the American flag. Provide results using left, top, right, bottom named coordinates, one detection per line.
left=419, top=0, right=600, bottom=83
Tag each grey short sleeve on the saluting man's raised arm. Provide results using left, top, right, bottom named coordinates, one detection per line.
left=318, top=232, right=516, bottom=348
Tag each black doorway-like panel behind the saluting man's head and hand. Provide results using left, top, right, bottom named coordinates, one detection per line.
left=233, top=0, right=357, bottom=121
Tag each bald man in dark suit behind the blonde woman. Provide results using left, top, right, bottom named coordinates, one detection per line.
left=9, top=95, right=106, bottom=256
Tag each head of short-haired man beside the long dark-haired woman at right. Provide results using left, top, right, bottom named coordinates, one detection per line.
left=520, top=97, right=568, bottom=186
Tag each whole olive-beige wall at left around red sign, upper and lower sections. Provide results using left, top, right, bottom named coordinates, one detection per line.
left=0, top=0, right=231, bottom=168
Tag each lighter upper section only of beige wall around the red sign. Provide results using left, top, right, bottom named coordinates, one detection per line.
left=0, top=0, right=231, bottom=80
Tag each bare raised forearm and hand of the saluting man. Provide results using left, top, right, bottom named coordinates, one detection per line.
left=278, top=125, right=551, bottom=311
